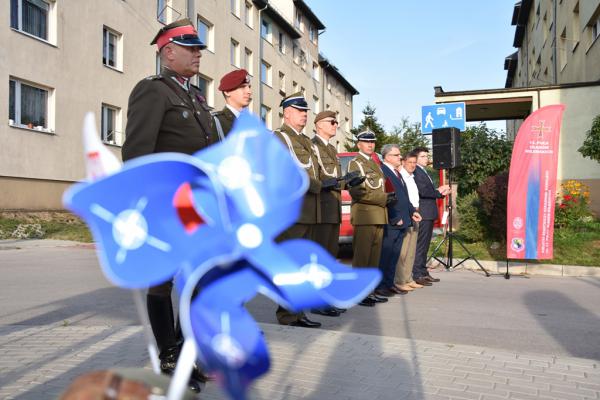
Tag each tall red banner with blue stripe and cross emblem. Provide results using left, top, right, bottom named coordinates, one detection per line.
left=506, top=104, right=565, bottom=260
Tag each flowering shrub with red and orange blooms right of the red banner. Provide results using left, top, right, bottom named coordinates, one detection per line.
left=554, top=180, right=592, bottom=228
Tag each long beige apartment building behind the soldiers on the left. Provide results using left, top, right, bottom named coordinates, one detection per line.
left=0, top=0, right=358, bottom=209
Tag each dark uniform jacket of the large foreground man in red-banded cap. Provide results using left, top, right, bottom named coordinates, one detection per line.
left=121, top=68, right=214, bottom=161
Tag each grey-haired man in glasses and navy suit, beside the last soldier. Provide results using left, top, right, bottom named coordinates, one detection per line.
left=375, top=144, right=421, bottom=297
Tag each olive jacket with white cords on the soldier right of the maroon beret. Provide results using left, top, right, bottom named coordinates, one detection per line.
left=274, top=124, right=321, bottom=224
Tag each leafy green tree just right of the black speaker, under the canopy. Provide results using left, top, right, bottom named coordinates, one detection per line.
left=454, top=123, right=512, bottom=195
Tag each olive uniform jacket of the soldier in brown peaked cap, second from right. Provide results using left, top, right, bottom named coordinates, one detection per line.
left=312, top=136, right=342, bottom=224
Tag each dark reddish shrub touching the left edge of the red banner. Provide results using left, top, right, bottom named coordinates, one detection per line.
left=477, top=172, right=508, bottom=240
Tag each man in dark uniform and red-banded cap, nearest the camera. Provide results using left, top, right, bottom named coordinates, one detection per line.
left=122, top=19, right=213, bottom=391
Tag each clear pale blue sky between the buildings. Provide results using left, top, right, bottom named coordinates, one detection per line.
left=305, top=0, right=516, bottom=131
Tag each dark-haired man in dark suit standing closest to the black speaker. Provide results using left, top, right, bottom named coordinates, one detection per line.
left=412, top=147, right=450, bottom=286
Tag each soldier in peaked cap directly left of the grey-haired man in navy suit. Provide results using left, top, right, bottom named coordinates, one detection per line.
left=348, top=131, right=392, bottom=307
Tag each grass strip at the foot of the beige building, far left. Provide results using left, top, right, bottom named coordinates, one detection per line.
left=0, top=211, right=92, bottom=243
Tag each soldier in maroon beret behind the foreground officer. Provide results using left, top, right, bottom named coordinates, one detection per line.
left=213, top=69, right=252, bottom=140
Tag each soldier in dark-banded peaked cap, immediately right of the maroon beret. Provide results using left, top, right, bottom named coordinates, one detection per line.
left=274, top=92, right=337, bottom=328
